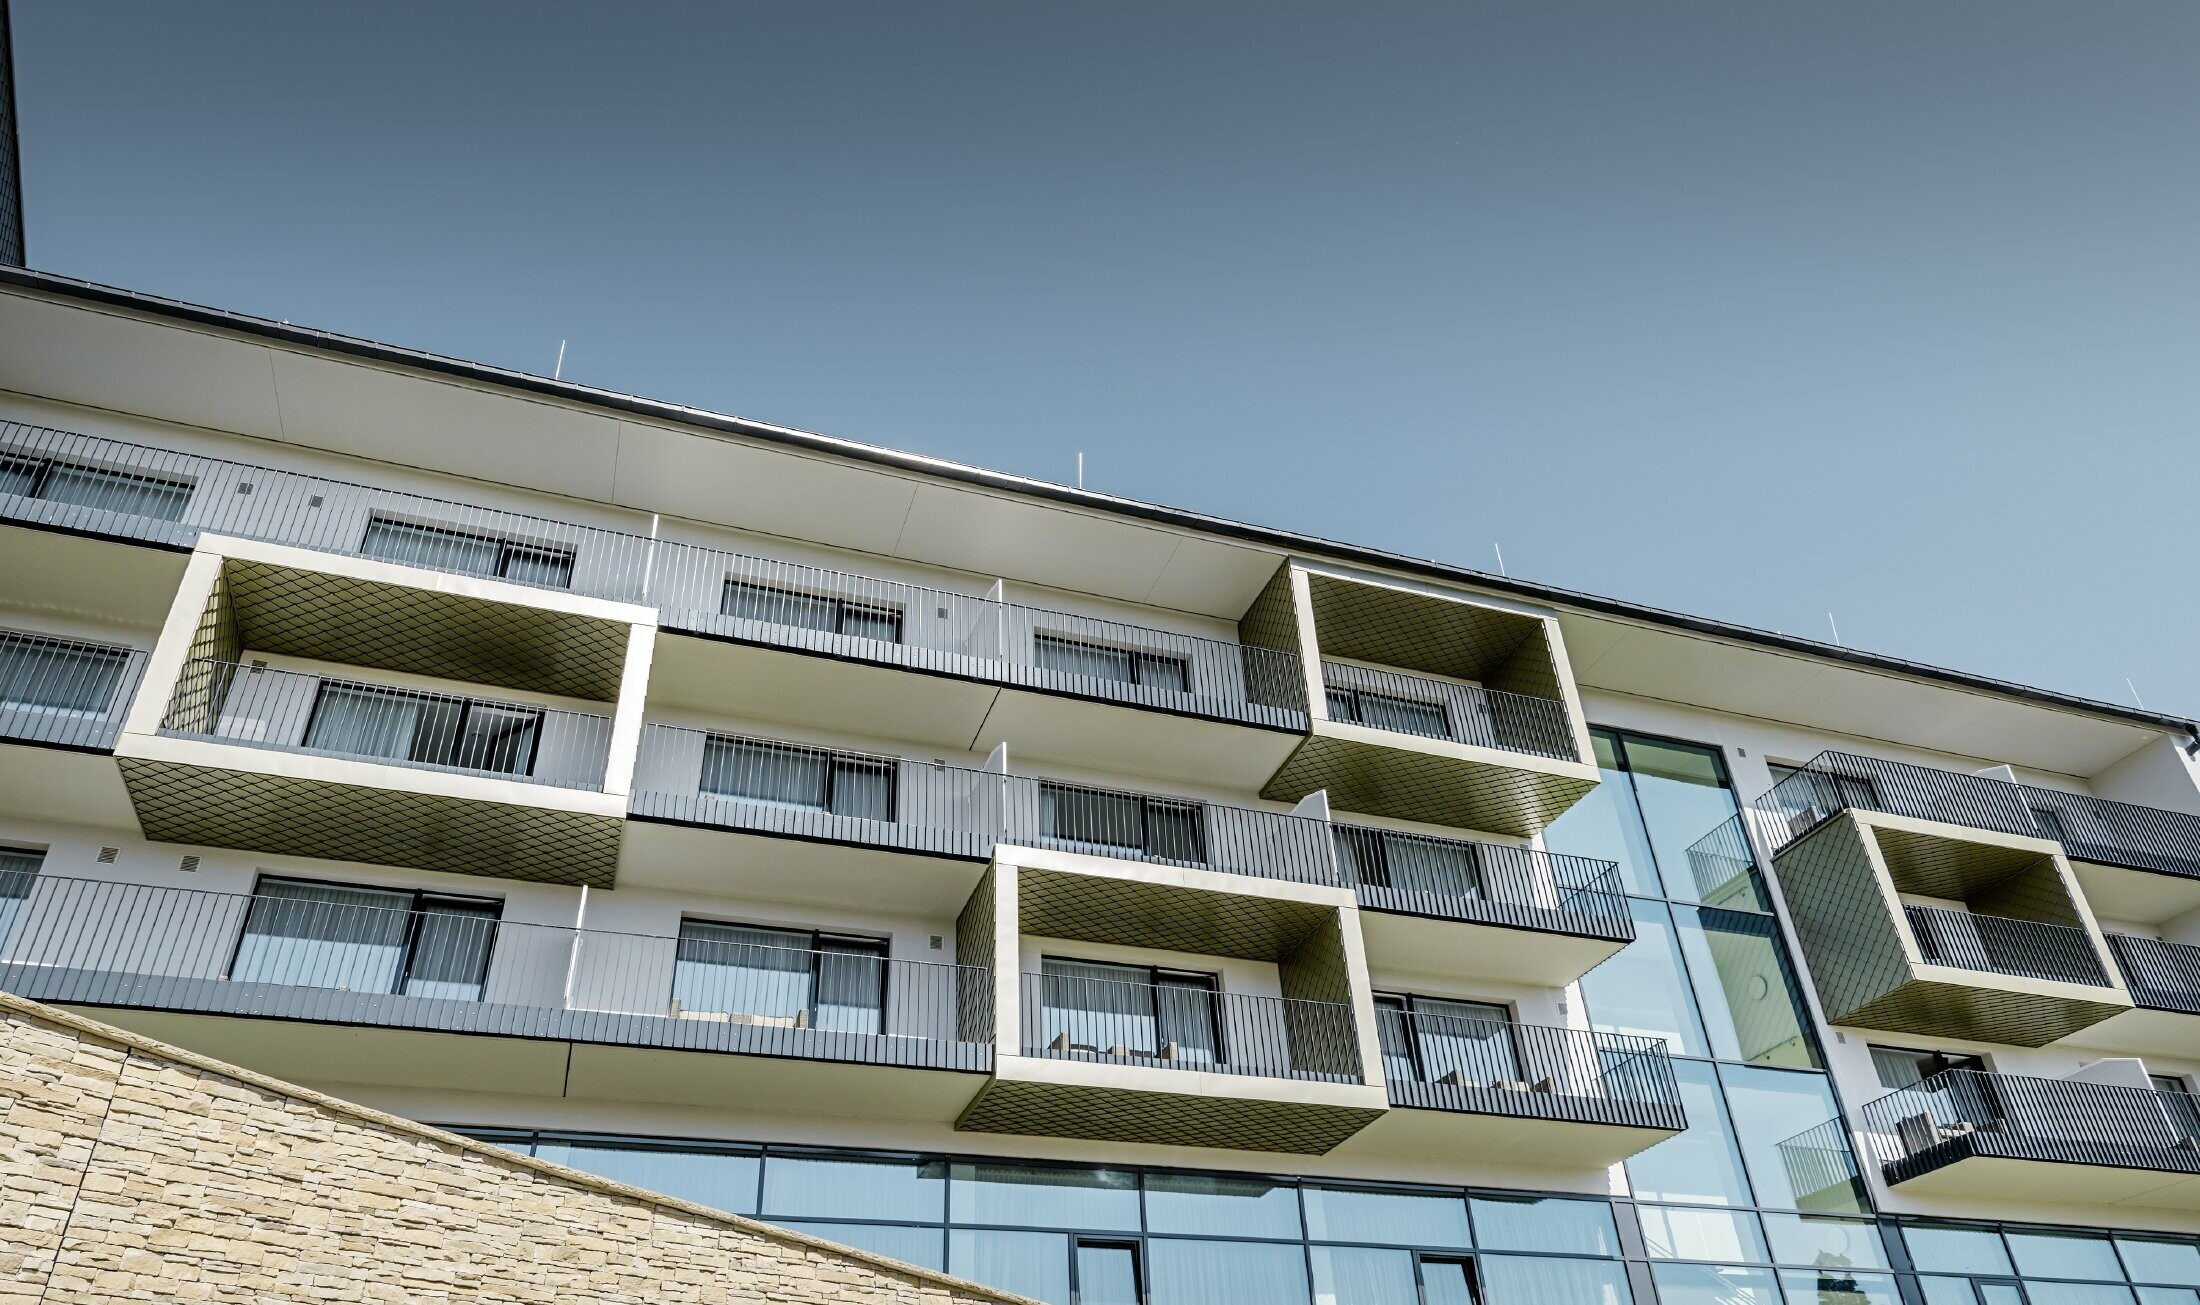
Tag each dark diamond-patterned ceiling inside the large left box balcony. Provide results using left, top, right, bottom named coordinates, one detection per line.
left=222, top=559, right=627, bottom=702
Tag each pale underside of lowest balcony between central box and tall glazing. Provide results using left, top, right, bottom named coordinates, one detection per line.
left=1346, top=1083, right=1687, bottom=1169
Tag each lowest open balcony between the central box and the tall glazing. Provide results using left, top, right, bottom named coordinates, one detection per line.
left=1353, top=1008, right=1687, bottom=1169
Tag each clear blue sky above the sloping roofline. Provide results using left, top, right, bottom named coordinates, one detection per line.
left=15, top=0, right=2200, bottom=713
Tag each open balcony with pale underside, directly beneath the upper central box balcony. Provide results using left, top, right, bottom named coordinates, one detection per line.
left=1333, top=823, right=1635, bottom=988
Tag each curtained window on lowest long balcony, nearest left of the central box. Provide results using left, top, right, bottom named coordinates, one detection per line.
left=673, top=920, right=887, bottom=1034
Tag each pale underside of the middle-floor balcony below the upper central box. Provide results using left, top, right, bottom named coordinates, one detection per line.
left=1360, top=906, right=1628, bottom=988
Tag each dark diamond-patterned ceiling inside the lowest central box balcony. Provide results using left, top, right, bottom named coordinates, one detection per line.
left=1016, top=867, right=1335, bottom=955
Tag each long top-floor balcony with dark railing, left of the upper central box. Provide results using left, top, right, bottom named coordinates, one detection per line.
left=0, top=423, right=1307, bottom=786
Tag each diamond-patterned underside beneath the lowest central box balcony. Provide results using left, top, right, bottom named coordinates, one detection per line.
left=955, top=1078, right=1384, bottom=1155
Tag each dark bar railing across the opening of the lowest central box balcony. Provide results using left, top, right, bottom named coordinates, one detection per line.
left=1023, top=975, right=1360, bottom=1083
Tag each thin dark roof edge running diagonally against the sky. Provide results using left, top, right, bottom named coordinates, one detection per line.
left=0, top=264, right=2200, bottom=739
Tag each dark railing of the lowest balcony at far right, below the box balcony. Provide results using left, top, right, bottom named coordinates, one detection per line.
left=1861, top=1070, right=2200, bottom=1184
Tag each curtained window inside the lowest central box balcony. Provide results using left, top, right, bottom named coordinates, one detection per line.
left=1038, top=955, right=1225, bottom=1065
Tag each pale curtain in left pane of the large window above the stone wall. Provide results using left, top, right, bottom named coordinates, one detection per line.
left=229, top=878, right=411, bottom=993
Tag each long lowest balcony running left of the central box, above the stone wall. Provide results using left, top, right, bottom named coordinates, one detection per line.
left=0, top=871, right=992, bottom=1122
